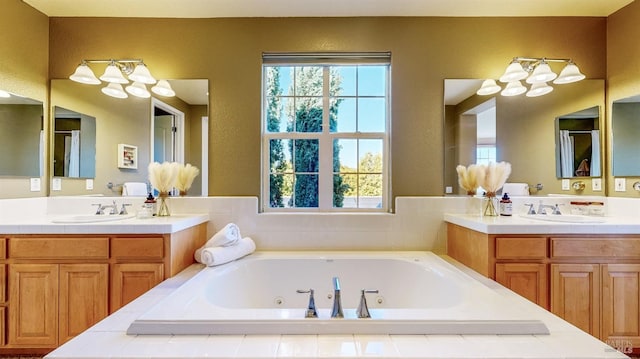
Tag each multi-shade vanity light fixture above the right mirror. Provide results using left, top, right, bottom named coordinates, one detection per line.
left=476, top=57, right=585, bottom=97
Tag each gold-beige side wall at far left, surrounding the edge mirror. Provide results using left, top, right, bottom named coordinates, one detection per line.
left=0, top=0, right=49, bottom=198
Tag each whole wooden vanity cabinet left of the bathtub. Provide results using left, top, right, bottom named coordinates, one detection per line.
left=0, top=223, right=206, bottom=353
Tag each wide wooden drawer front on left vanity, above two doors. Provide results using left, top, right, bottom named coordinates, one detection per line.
left=9, top=237, right=109, bottom=260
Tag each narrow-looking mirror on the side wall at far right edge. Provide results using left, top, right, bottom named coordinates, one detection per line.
left=611, top=95, right=640, bottom=177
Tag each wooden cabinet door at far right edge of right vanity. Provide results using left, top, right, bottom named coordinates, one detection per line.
left=602, top=264, right=640, bottom=348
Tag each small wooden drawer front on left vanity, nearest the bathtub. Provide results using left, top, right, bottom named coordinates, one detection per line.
left=111, top=237, right=164, bottom=260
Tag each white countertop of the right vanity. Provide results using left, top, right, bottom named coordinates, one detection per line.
left=444, top=213, right=640, bottom=234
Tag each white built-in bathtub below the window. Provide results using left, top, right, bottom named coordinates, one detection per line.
left=127, top=252, right=549, bottom=335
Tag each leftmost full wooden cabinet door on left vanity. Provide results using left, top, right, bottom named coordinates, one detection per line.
left=8, top=264, right=58, bottom=348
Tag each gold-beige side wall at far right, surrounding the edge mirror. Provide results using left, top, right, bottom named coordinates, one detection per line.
left=606, top=1, right=640, bottom=197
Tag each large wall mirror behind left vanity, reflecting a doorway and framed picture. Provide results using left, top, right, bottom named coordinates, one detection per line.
left=51, top=79, right=209, bottom=196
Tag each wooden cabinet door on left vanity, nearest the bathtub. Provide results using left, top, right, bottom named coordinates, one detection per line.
left=111, top=263, right=164, bottom=312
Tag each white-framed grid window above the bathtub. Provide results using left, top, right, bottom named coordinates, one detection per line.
left=262, top=53, right=389, bottom=211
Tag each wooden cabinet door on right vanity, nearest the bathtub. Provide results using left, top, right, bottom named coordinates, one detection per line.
left=496, top=263, right=549, bottom=309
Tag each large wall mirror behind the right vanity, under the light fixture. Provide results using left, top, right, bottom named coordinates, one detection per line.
left=443, top=79, right=605, bottom=195
